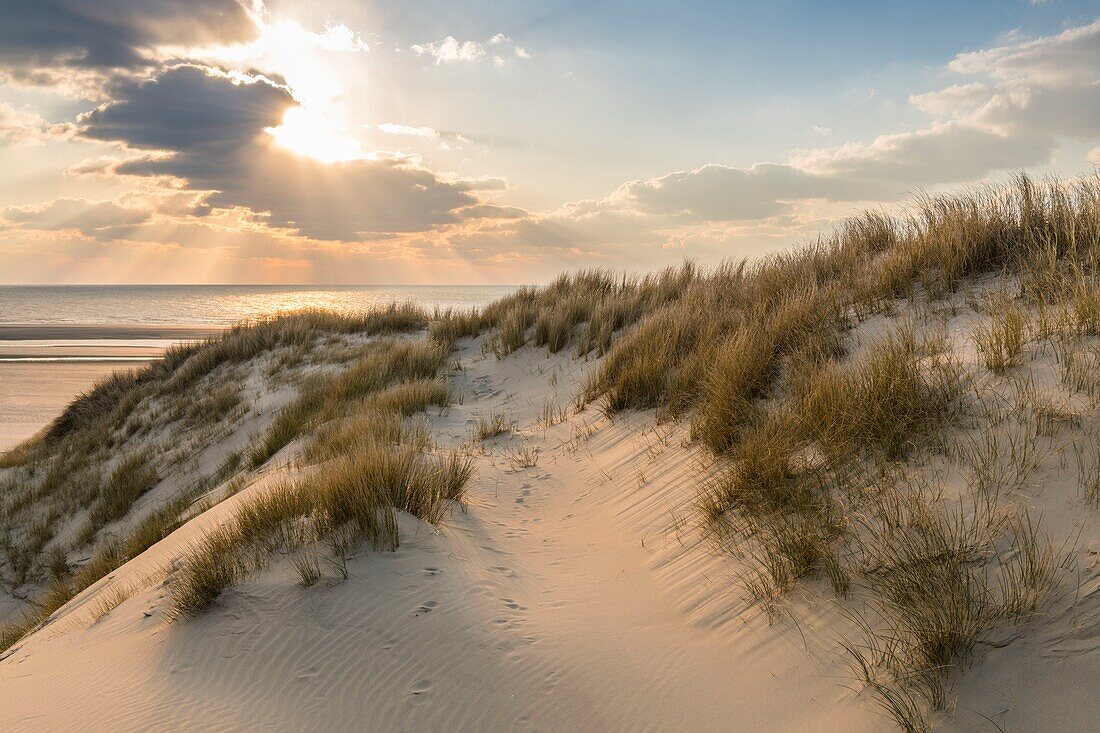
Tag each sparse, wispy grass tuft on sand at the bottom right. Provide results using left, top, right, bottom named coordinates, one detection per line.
left=844, top=490, right=1065, bottom=731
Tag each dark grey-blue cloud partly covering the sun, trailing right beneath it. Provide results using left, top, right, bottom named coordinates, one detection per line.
left=80, top=65, right=490, bottom=241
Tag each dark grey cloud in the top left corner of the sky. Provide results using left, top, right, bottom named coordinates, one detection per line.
left=0, top=0, right=255, bottom=91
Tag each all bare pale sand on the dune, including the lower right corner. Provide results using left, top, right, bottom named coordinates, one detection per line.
left=0, top=294, right=1100, bottom=733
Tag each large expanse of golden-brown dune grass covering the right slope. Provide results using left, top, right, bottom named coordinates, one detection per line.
left=525, top=176, right=1100, bottom=730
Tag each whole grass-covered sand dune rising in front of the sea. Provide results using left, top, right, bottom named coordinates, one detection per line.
left=0, top=180, right=1100, bottom=733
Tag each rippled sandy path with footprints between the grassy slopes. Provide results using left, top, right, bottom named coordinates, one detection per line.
left=0, top=400, right=883, bottom=731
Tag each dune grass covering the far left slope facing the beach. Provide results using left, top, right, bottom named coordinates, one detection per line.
left=0, top=305, right=429, bottom=638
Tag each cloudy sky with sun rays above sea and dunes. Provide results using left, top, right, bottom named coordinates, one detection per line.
left=0, top=0, right=1100, bottom=284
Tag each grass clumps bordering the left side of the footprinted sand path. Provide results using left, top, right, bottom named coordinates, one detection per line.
left=169, top=331, right=464, bottom=619
